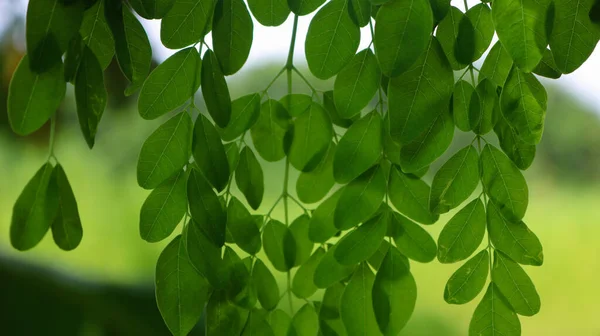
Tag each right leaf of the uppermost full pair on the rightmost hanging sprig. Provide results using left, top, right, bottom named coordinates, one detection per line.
left=480, top=145, right=529, bottom=221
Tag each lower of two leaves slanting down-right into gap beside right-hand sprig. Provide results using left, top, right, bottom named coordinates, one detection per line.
left=390, top=211, right=437, bottom=263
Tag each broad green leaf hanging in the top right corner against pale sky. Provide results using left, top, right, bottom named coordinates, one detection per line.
left=549, top=0, right=600, bottom=74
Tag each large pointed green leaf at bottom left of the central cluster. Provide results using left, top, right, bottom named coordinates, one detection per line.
left=156, top=236, right=209, bottom=335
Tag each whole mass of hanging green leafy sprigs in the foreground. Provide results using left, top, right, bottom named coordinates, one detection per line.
left=8, top=0, right=600, bottom=336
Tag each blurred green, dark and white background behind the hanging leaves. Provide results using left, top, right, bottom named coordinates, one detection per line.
left=0, top=0, right=600, bottom=336
